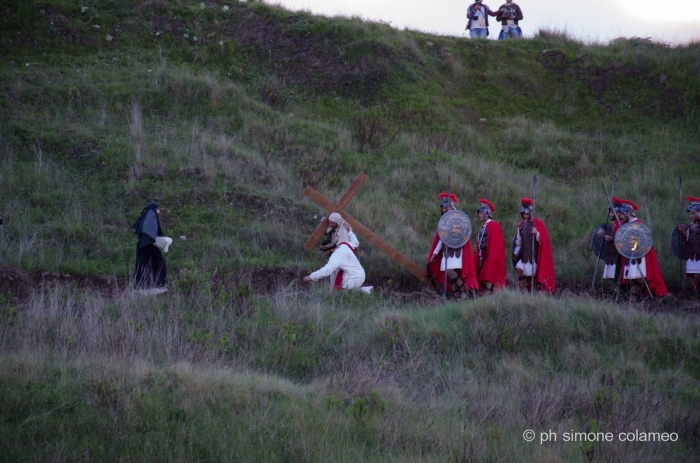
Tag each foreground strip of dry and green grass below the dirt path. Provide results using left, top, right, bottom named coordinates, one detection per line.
left=0, top=288, right=700, bottom=462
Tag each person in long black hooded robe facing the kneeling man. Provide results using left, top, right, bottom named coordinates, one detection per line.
left=131, top=203, right=168, bottom=289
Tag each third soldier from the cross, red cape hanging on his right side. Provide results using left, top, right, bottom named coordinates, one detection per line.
left=513, top=198, right=556, bottom=293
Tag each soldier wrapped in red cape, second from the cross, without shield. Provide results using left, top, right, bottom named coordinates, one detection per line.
left=474, top=198, right=506, bottom=295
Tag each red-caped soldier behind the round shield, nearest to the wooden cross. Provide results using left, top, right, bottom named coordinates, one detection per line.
left=425, top=191, right=479, bottom=299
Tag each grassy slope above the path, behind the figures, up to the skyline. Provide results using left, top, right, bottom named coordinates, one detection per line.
left=0, top=0, right=700, bottom=285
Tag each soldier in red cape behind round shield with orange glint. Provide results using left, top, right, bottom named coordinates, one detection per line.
left=617, top=199, right=668, bottom=302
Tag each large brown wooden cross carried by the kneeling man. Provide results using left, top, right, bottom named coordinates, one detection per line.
left=304, top=172, right=428, bottom=284
